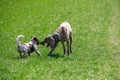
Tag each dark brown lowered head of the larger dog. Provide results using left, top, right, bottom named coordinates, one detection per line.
left=40, top=35, right=55, bottom=48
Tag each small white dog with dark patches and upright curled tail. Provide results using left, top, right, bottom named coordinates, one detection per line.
left=16, top=35, right=42, bottom=58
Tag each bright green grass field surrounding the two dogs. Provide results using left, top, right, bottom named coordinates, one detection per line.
left=0, top=0, right=120, bottom=80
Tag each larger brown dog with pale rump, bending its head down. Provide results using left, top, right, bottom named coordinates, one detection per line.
left=40, top=22, right=72, bottom=56
